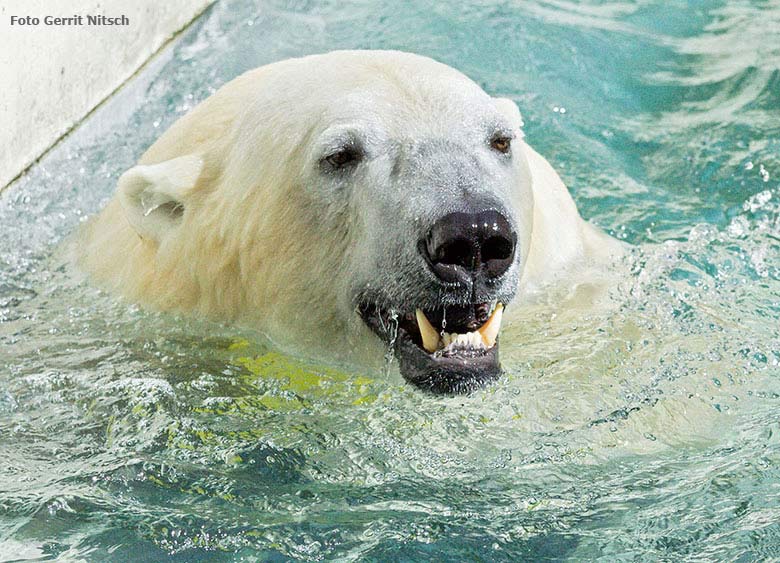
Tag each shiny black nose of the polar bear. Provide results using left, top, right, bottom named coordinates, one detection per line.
left=420, top=210, right=517, bottom=282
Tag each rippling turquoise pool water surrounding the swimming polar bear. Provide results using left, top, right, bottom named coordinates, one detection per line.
left=0, top=0, right=780, bottom=561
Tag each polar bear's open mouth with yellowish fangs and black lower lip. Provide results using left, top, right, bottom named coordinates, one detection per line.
left=359, top=302, right=504, bottom=393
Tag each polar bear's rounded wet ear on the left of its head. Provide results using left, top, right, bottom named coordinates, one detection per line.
left=117, top=155, right=203, bottom=242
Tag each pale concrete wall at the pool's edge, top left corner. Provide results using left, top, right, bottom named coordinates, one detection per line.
left=0, top=0, right=212, bottom=189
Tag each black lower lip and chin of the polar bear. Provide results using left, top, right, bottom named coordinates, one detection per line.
left=359, top=302, right=502, bottom=395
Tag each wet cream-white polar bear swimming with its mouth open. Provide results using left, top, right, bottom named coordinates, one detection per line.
left=77, top=51, right=617, bottom=393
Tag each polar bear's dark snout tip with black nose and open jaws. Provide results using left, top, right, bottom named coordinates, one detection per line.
left=357, top=208, right=521, bottom=394
